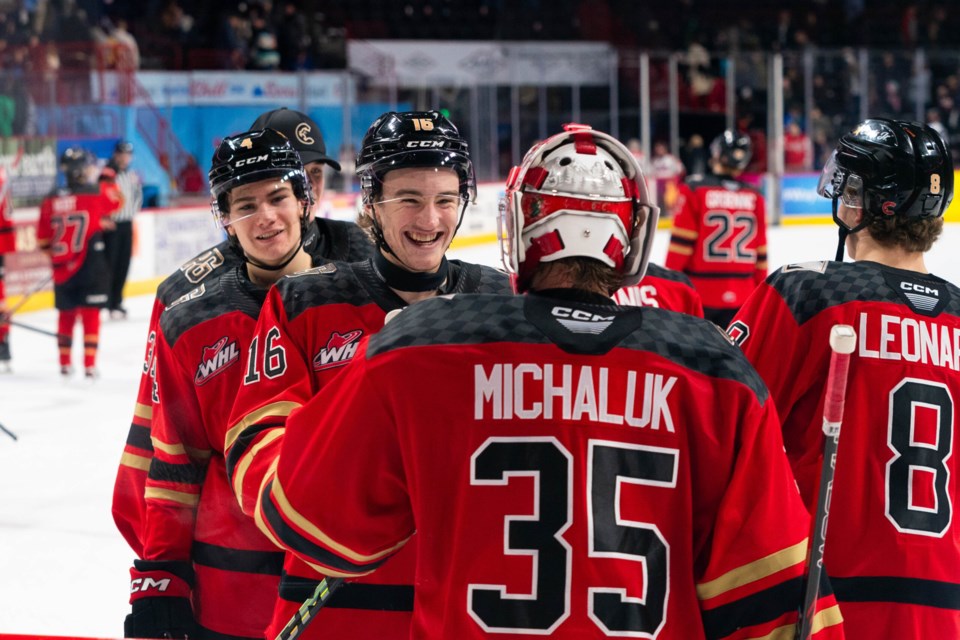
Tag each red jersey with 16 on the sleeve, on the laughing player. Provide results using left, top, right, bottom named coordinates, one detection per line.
left=226, top=260, right=510, bottom=640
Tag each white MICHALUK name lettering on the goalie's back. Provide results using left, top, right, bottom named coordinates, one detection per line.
left=473, top=362, right=677, bottom=433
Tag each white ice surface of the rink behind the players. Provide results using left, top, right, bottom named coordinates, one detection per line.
left=0, top=224, right=960, bottom=637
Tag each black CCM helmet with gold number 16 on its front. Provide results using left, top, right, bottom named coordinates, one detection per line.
left=357, top=111, right=477, bottom=203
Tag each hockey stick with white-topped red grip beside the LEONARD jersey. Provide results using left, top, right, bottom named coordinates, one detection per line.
left=797, top=324, right=857, bottom=640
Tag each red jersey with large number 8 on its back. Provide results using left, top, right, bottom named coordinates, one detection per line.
left=728, top=262, right=960, bottom=638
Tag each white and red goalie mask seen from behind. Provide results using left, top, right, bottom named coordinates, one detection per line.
left=500, top=124, right=660, bottom=292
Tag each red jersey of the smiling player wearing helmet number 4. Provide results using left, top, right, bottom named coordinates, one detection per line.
left=142, top=265, right=283, bottom=638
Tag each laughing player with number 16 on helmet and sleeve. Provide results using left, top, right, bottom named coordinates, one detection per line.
left=226, top=111, right=510, bottom=640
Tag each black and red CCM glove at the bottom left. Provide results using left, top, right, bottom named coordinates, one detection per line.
left=123, top=560, right=199, bottom=639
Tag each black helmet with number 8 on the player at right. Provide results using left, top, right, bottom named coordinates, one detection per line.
left=817, top=118, right=953, bottom=232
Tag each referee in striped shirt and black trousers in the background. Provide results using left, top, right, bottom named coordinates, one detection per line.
left=100, top=140, right=143, bottom=320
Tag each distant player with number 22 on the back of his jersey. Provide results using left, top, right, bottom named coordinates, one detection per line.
left=665, top=130, right=767, bottom=327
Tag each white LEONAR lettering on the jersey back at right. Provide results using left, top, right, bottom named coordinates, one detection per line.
left=857, top=312, right=960, bottom=371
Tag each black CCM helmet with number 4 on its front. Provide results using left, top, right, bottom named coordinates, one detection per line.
left=208, top=129, right=313, bottom=224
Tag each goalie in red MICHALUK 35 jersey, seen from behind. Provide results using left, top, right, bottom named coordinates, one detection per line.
left=251, top=125, right=842, bottom=640
